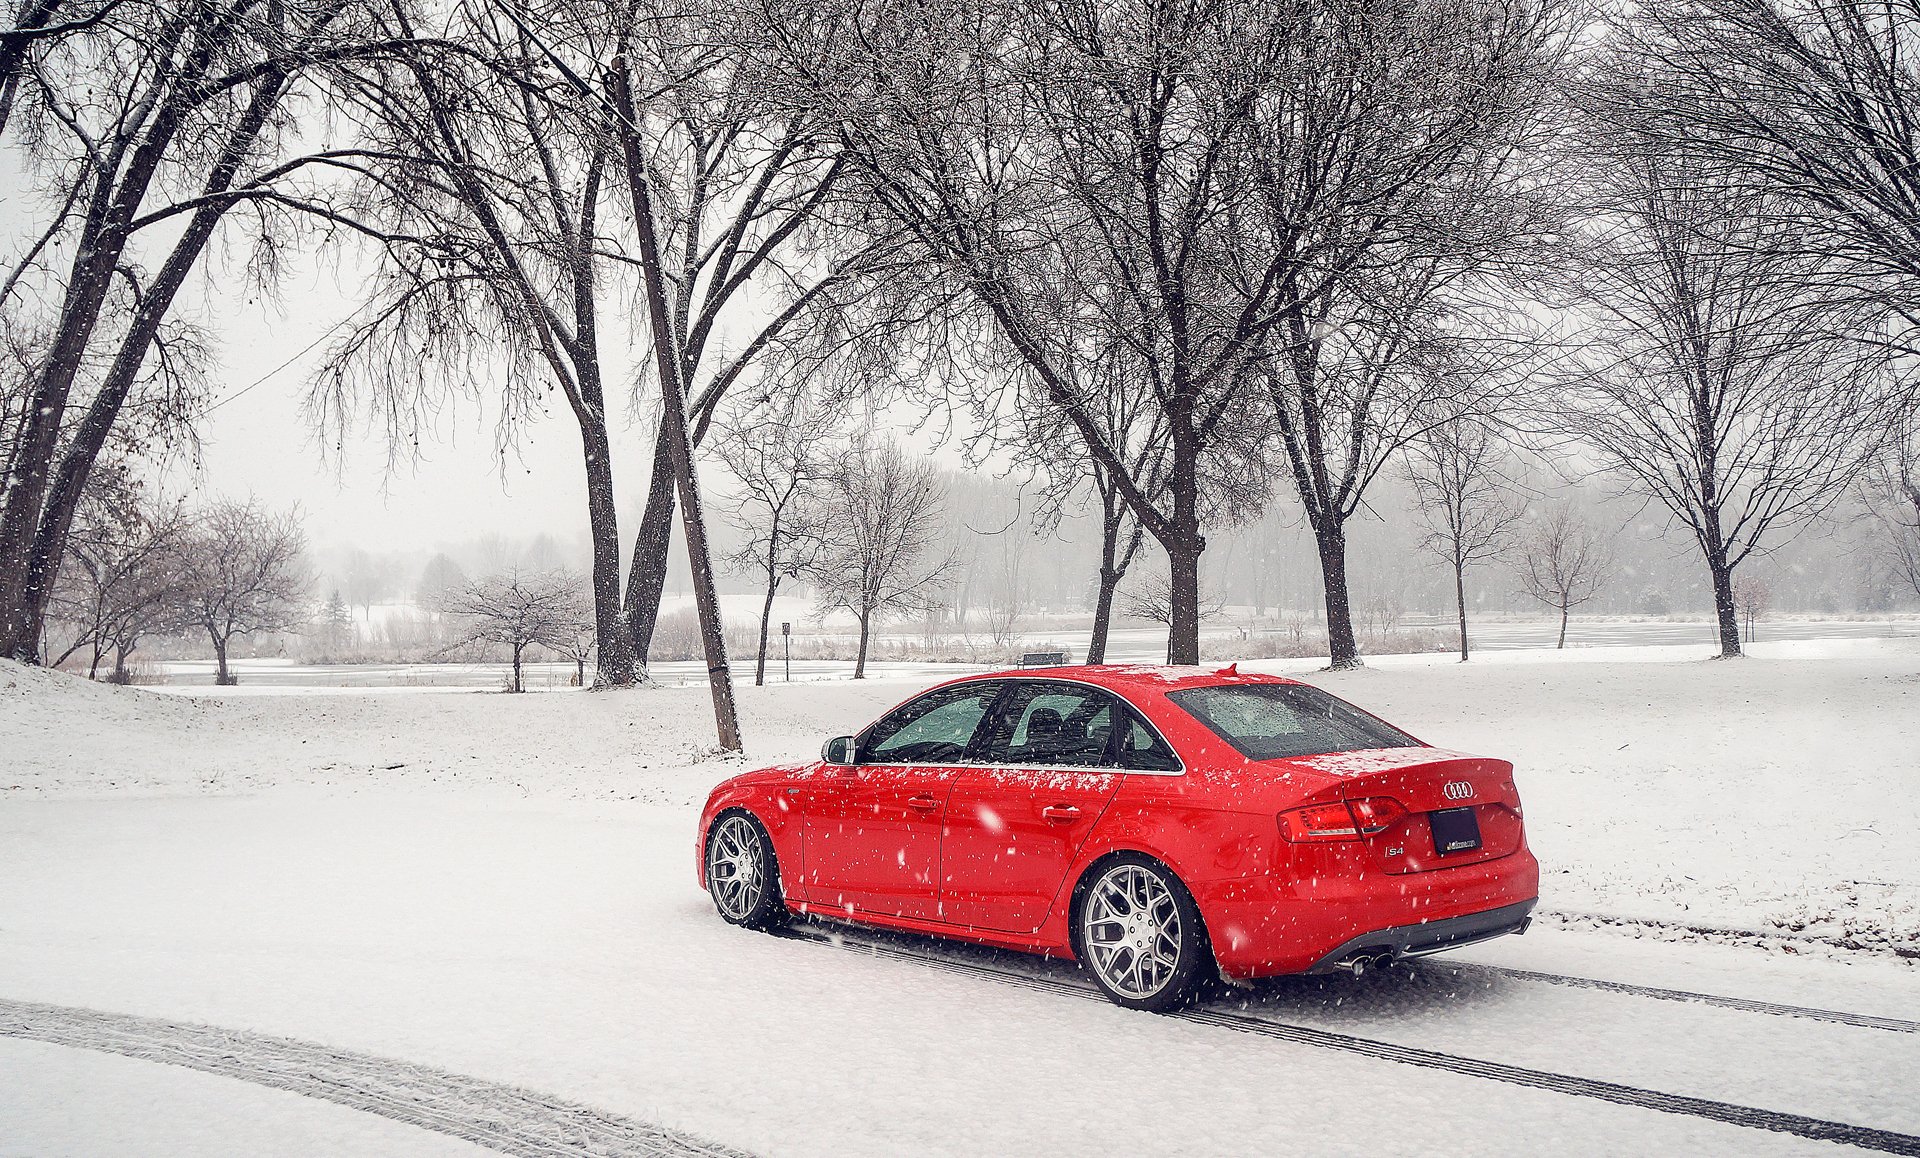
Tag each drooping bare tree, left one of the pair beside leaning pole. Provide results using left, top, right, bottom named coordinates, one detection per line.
left=309, top=0, right=639, bottom=686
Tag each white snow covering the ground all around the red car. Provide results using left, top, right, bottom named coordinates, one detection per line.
left=0, top=639, right=1920, bottom=1156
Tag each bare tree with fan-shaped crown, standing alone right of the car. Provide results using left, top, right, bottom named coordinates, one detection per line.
left=1551, top=132, right=1907, bottom=657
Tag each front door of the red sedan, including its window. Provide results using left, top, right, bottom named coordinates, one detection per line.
left=801, top=682, right=1002, bottom=920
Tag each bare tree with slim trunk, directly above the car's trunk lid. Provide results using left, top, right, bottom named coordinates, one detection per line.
left=1254, top=0, right=1584, bottom=668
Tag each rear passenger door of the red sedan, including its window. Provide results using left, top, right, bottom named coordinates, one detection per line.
left=941, top=680, right=1131, bottom=933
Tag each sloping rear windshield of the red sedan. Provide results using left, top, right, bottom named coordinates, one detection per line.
left=1167, top=684, right=1421, bottom=760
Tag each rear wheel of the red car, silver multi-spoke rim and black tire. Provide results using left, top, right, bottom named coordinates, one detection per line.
left=1069, top=853, right=1217, bottom=1014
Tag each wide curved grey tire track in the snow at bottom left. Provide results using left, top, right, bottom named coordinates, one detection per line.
left=0, top=999, right=764, bottom=1158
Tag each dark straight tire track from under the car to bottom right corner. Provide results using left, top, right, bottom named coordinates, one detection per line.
left=780, top=929, right=1920, bottom=1156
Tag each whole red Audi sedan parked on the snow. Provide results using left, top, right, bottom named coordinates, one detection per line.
left=699, top=666, right=1540, bottom=1010
